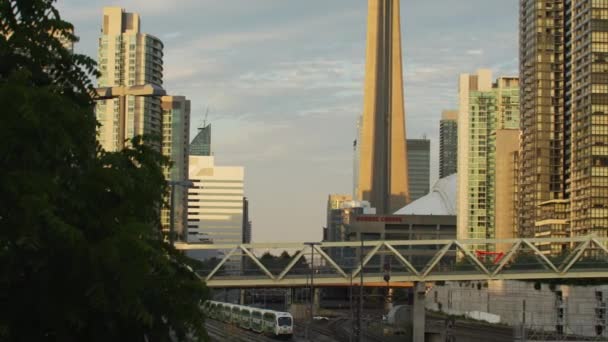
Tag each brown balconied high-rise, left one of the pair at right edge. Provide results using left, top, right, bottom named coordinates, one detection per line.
left=518, top=0, right=568, bottom=237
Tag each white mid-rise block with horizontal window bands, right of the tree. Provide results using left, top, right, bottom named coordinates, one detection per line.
left=188, top=156, right=245, bottom=244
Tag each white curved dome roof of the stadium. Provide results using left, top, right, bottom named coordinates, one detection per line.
left=395, top=174, right=457, bottom=215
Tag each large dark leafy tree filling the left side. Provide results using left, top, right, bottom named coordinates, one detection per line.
left=0, top=0, right=207, bottom=341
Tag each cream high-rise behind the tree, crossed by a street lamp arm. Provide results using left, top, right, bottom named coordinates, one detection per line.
left=96, top=7, right=163, bottom=151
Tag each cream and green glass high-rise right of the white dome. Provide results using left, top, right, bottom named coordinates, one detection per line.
left=457, top=70, right=519, bottom=246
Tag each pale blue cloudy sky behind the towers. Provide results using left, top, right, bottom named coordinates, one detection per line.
left=57, top=0, right=518, bottom=242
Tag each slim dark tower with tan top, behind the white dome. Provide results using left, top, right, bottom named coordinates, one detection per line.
left=439, top=110, right=458, bottom=178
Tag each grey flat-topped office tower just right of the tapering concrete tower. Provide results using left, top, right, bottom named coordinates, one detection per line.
left=407, top=139, right=431, bottom=201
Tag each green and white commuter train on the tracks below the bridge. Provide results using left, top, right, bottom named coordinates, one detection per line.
left=203, top=300, right=293, bottom=339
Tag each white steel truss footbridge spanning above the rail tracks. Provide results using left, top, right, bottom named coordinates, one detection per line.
left=175, top=236, right=608, bottom=288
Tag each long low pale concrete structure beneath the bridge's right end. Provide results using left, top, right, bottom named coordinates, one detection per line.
left=426, top=281, right=608, bottom=341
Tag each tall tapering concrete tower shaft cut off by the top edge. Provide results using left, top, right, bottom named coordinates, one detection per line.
left=357, top=0, right=409, bottom=214
